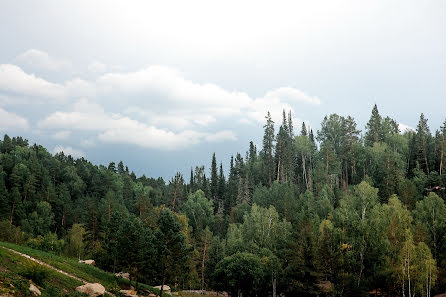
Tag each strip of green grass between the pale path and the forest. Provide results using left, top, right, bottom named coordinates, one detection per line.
left=0, top=242, right=159, bottom=294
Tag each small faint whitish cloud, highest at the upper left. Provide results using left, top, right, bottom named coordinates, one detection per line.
left=17, top=49, right=71, bottom=71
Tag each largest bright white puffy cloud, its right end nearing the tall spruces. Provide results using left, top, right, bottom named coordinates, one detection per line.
left=96, top=66, right=321, bottom=127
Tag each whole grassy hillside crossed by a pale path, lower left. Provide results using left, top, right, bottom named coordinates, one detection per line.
left=0, top=242, right=159, bottom=297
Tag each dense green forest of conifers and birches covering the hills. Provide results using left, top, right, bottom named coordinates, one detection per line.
left=0, top=105, right=446, bottom=297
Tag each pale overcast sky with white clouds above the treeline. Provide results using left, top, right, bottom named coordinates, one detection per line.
left=0, top=0, right=446, bottom=180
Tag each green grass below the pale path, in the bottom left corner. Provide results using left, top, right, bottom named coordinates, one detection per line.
left=0, top=248, right=84, bottom=297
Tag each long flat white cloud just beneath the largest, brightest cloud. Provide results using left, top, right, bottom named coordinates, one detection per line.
left=38, top=99, right=237, bottom=150
